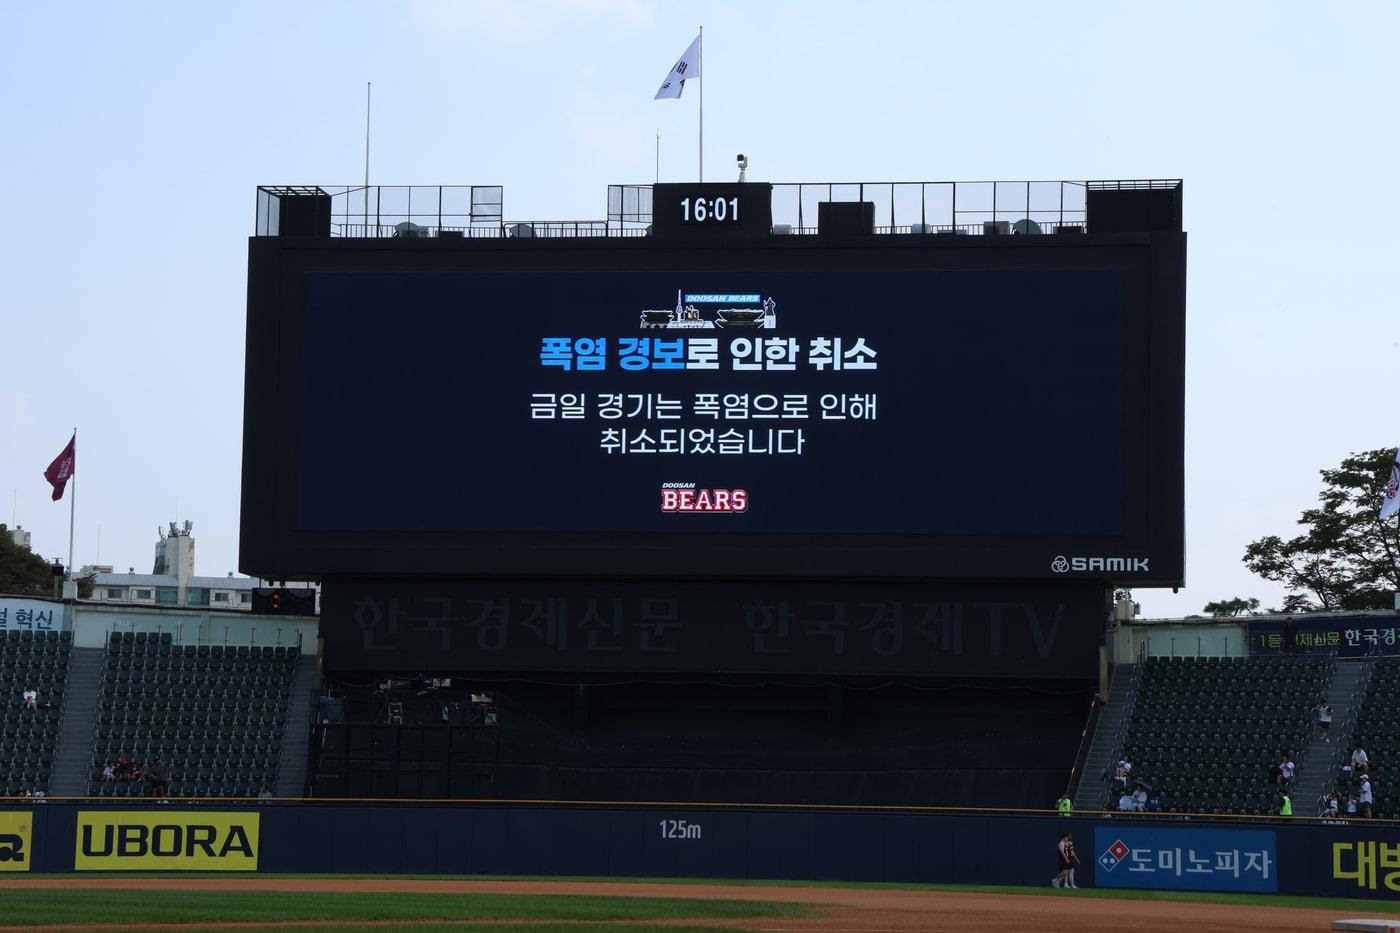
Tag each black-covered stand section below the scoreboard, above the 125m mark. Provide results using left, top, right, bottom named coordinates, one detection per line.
left=309, top=678, right=1092, bottom=807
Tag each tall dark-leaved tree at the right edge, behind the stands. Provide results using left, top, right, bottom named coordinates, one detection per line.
left=1243, top=447, right=1400, bottom=612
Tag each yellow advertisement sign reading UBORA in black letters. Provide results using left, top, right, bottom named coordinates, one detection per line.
left=73, top=810, right=259, bottom=871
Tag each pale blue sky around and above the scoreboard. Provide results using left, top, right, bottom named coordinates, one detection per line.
left=0, top=0, right=1400, bottom=616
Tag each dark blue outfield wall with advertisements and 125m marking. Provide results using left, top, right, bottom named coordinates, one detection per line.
left=0, top=801, right=1400, bottom=899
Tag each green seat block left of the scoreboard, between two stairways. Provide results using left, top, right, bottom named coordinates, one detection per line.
left=88, top=632, right=300, bottom=797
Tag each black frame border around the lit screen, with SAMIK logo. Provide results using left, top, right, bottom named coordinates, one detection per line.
left=239, top=233, right=1186, bottom=586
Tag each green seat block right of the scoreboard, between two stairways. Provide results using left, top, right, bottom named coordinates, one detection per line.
left=1103, top=657, right=1331, bottom=814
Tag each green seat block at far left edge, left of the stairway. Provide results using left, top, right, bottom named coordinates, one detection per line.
left=0, top=629, right=73, bottom=797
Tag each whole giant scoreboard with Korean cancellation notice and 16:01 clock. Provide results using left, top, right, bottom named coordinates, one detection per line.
left=241, top=215, right=1186, bottom=586
